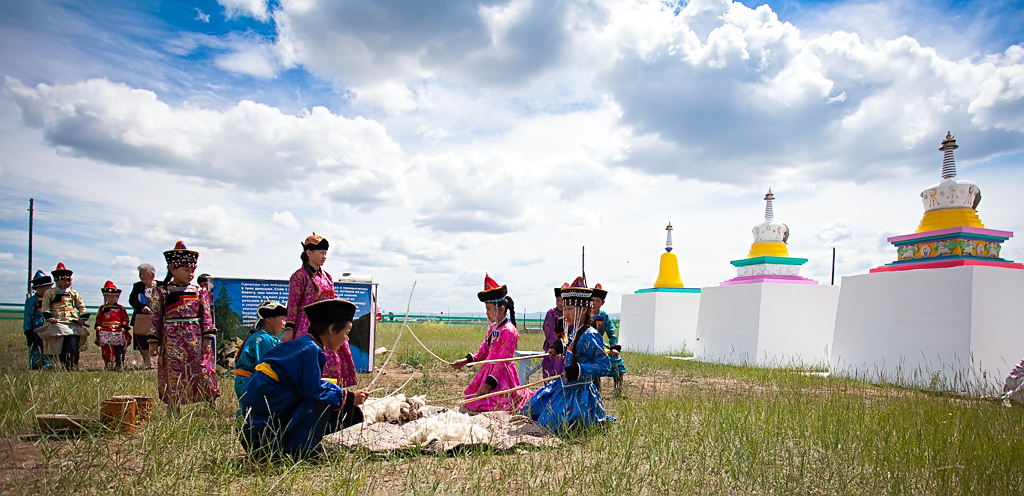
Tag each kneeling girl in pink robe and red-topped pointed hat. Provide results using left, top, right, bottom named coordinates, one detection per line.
left=452, top=275, right=531, bottom=412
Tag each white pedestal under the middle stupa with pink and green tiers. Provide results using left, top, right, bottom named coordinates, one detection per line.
left=693, top=283, right=839, bottom=367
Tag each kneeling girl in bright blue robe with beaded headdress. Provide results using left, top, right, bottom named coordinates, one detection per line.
left=522, top=278, right=615, bottom=431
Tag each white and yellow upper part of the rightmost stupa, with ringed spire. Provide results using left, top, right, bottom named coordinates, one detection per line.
left=916, top=132, right=985, bottom=233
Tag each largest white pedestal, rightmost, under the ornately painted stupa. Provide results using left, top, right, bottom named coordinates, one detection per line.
left=831, top=266, right=1024, bottom=395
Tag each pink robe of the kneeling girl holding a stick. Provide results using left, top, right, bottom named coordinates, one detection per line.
left=466, top=319, right=534, bottom=412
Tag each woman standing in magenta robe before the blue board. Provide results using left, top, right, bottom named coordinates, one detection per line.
left=282, top=233, right=355, bottom=387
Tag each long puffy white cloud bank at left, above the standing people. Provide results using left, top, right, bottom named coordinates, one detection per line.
left=6, top=78, right=403, bottom=203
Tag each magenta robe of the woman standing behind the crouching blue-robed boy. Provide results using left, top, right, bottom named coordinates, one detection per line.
left=287, top=266, right=356, bottom=387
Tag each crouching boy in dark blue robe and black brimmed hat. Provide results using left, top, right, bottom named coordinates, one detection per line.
left=239, top=299, right=369, bottom=456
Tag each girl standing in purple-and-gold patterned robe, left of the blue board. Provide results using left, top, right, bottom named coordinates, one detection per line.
left=150, top=241, right=220, bottom=410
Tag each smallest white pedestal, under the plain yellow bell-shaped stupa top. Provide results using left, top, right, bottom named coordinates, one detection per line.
left=618, top=291, right=700, bottom=354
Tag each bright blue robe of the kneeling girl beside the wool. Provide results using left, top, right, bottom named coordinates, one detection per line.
left=522, top=327, right=615, bottom=431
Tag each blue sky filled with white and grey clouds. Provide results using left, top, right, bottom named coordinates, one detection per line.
left=0, top=0, right=1024, bottom=314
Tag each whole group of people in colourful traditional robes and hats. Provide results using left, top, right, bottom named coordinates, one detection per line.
left=26, top=234, right=626, bottom=454
